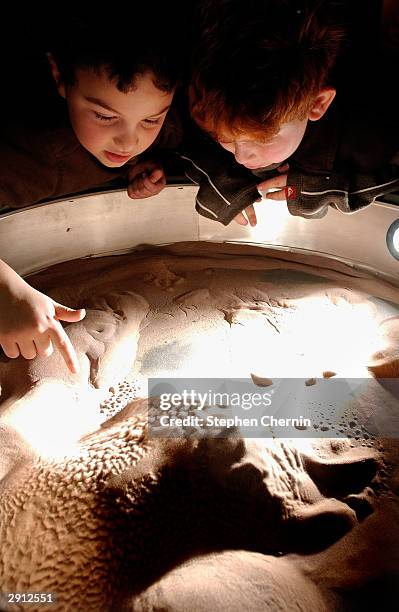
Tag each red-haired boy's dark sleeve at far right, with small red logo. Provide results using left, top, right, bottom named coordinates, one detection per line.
left=276, top=106, right=399, bottom=219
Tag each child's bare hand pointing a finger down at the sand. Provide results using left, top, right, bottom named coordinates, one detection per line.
left=0, top=260, right=86, bottom=373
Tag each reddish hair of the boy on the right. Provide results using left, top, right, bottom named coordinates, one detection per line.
left=190, top=0, right=345, bottom=140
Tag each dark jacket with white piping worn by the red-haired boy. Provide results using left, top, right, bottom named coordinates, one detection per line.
left=181, top=100, right=399, bottom=225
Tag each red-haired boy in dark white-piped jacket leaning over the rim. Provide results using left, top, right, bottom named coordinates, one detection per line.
left=183, top=0, right=399, bottom=225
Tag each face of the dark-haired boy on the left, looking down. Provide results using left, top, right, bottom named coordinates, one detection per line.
left=58, top=68, right=173, bottom=168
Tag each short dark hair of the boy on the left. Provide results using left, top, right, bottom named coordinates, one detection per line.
left=48, top=0, right=187, bottom=93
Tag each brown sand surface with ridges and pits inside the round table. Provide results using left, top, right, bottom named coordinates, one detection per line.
left=0, top=243, right=399, bottom=611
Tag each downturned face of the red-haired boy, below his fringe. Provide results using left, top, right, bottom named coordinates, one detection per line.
left=218, top=119, right=308, bottom=170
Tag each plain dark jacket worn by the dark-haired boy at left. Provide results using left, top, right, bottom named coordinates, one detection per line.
left=0, top=110, right=179, bottom=212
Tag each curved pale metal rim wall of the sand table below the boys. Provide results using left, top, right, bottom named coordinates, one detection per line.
left=0, top=185, right=399, bottom=284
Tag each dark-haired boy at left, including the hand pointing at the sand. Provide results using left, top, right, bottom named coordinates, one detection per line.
left=0, top=2, right=183, bottom=372
